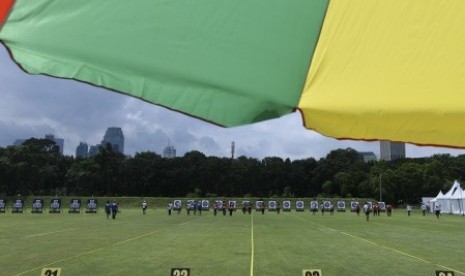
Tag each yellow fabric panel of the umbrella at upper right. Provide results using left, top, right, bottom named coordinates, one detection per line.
left=298, top=0, right=465, bottom=147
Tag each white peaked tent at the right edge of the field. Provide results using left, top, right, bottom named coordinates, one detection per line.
left=432, top=181, right=465, bottom=215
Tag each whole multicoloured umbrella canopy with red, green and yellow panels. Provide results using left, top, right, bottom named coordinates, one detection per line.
left=0, top=0, right=465, bottom=147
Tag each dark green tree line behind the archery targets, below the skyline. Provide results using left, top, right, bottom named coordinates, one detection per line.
left=0, top=138, right=465, bottom=204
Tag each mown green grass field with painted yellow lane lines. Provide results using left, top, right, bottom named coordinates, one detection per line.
left=0, top=208, right=465, bottom=276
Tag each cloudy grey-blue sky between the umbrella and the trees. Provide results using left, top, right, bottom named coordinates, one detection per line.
left=0, top=45, right=465, bottom=160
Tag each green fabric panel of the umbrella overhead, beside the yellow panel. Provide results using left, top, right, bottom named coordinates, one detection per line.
left=0, top=0, right=328, bottom=126
